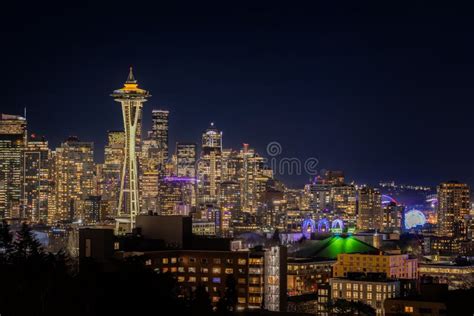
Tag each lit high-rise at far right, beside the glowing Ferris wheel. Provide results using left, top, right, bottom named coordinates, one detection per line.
left=438, top=181, right=471, bottom=238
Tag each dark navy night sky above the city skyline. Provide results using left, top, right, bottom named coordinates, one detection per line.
left=0, top=1, right=474, bottom=185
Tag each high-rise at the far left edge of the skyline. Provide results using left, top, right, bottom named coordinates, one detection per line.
left=0, top=114, right=26, bottom=218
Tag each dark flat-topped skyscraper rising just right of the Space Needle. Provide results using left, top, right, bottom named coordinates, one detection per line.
left=150, top=110, right=169, bottom=165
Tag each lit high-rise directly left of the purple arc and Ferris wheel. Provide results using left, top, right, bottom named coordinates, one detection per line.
left=357, top=187, right=383, bottom=230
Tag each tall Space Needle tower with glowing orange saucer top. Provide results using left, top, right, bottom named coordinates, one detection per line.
left=112, top=67, right=151, bottom=229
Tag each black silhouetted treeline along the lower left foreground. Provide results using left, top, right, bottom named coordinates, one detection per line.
left=0, top=222, right=237, bottom=316
